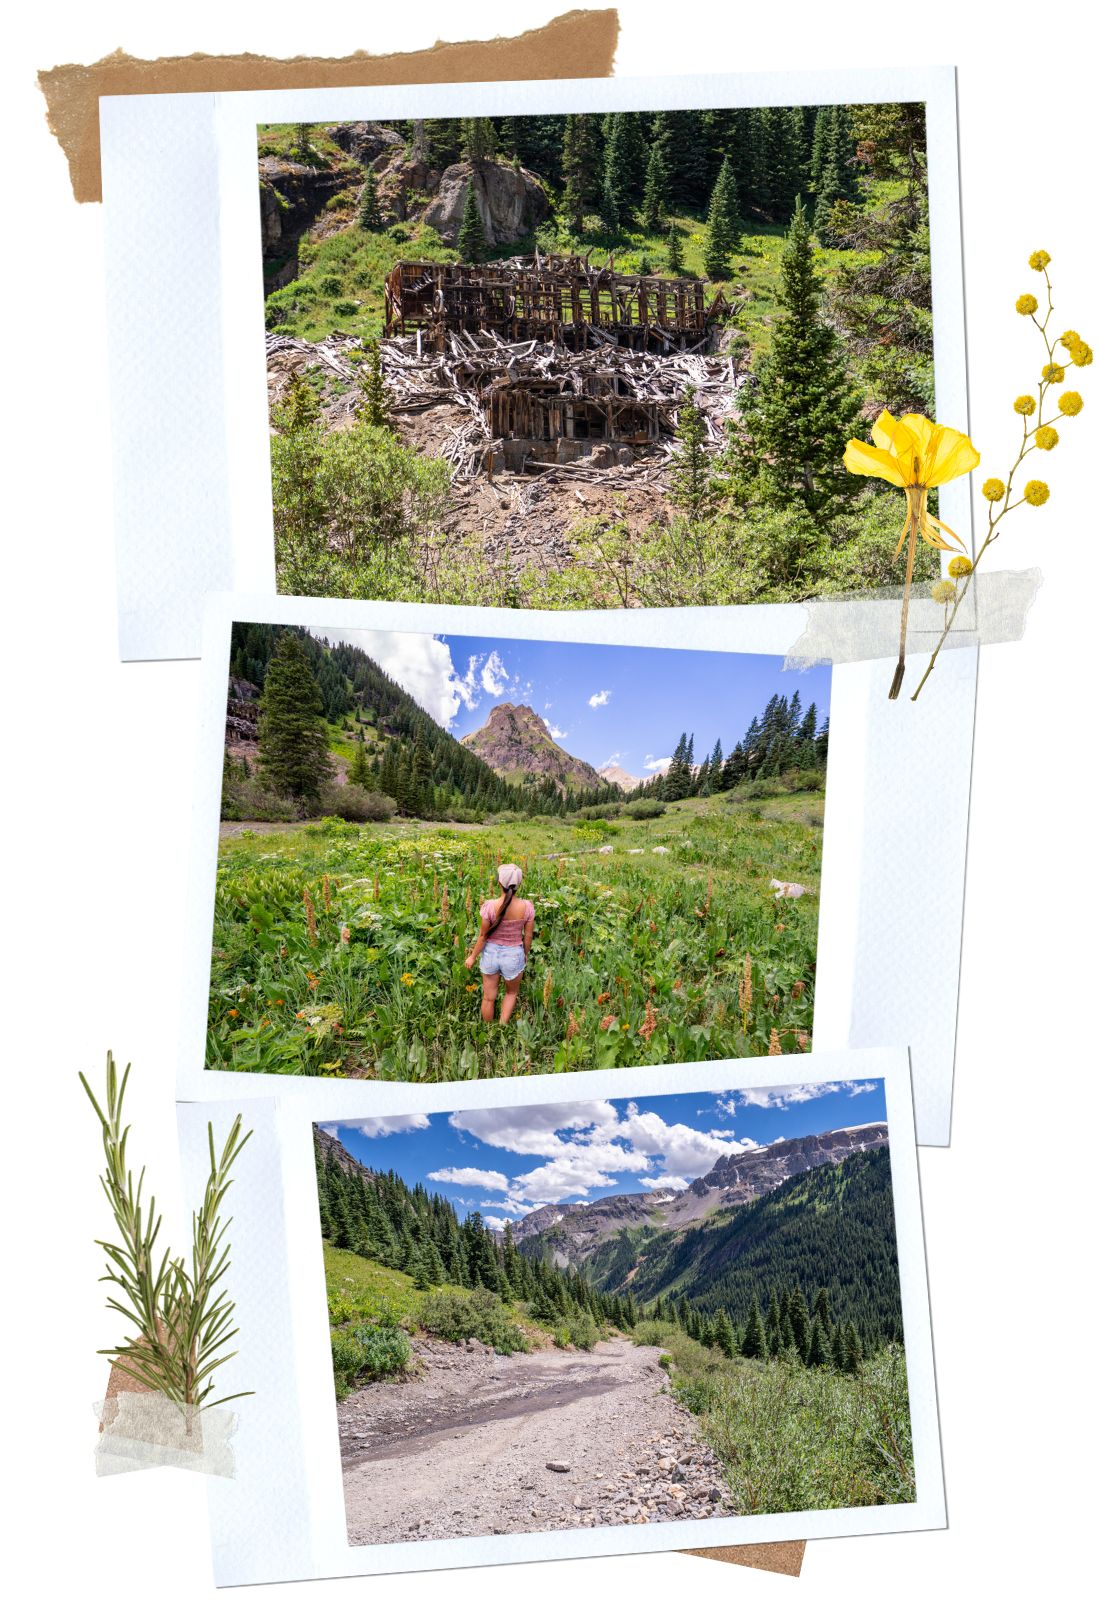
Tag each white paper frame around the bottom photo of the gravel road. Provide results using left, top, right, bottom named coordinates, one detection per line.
left=179, top=1050, right=947, bottom=1586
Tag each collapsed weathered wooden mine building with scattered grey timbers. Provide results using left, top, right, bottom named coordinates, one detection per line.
left=385, top=256, right=731, bottom=472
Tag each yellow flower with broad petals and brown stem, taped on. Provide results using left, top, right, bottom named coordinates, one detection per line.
left=844, top=411, right=982, bottom=699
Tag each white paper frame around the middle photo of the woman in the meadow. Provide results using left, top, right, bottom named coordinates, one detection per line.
left=177, top=595, right=977, bottom=1144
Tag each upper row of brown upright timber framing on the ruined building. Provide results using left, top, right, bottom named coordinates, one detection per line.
left=385, top=254, right=731, bottom=350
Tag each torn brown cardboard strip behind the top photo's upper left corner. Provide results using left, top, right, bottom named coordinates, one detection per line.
left=38, top=8, right=619, bottom=203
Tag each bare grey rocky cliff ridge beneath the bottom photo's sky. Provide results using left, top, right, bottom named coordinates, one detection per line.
left=512, top=1122, right=889, bottom=1266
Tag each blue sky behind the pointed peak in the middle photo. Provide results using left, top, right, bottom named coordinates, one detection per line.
left=317, top=629, right=830, bottom=778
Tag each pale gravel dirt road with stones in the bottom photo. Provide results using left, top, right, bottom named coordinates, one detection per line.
left=339, top=1338, right=729, bottom=1544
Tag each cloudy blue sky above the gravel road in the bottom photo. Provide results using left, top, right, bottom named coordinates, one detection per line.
left=321, top=1078, right=886, bottom=1229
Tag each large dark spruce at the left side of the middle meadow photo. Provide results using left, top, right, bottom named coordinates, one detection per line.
left=259, top=629, right=331, bottom=806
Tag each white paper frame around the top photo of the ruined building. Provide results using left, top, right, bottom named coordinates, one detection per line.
left=101, top=66, right=970, bottom=661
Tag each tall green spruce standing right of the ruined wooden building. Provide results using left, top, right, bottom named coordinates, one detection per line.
left=740, top=200, right=860, bottom=520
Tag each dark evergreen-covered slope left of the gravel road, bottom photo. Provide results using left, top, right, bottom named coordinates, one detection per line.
left=313, top=1128, right=638, bottom=1328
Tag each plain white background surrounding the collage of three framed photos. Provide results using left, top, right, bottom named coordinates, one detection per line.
left=0, top=0, right=1100, bottom=1600
